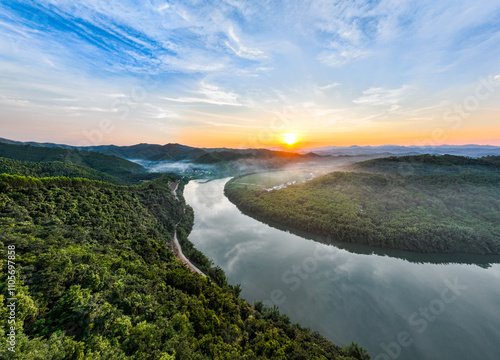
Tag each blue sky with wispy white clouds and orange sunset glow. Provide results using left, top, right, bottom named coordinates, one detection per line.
left=0, top=0, right=500, bottom=148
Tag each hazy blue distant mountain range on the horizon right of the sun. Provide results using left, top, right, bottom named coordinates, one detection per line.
left=301, top=144, right=500, bottom=157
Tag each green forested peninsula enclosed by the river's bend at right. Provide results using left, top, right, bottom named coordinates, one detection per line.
left=225, top=155, right=500, bottom=254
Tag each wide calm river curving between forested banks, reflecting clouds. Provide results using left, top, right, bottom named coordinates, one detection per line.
left=184, top=179, right=500, bottom=360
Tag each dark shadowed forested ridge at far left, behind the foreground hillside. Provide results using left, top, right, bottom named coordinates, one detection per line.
left=0, top=143, right=145, bottom=180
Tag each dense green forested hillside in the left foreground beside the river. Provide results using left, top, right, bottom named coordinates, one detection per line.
left=0, top=175, right=368, bottom=360
